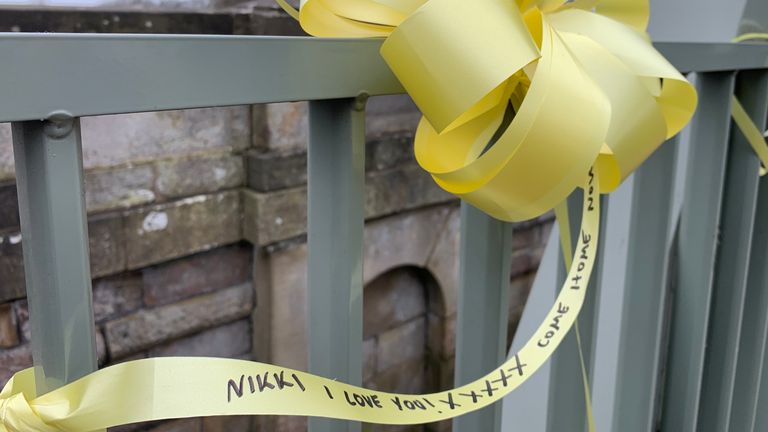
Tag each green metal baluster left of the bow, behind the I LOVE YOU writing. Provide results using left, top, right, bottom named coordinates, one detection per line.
left=307, top=97, right=365, bottom=432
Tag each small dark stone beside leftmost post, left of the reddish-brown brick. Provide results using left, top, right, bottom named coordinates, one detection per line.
left=93, top=273, right=142, bottom=323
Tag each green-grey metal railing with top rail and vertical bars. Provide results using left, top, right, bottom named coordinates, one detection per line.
left=0, top=34, right=768, bottom=432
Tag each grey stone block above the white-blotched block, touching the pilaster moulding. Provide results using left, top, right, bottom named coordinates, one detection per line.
left=155, top=154, right=245, bottom=199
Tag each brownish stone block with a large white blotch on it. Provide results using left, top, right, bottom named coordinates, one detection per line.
left=125, top=191, right=241, bottom=269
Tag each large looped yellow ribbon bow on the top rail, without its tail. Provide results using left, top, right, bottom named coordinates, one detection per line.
left=288, top=0, right=697, bottom=221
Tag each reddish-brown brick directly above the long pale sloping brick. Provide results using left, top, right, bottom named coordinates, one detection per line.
left=142, top=245, right=251, bottom=306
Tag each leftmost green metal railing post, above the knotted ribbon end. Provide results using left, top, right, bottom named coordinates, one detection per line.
left=13, top=116, right=98, bottom=394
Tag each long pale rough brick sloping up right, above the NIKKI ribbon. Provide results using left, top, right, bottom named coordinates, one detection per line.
left=105, top=284, right=253, bottom=358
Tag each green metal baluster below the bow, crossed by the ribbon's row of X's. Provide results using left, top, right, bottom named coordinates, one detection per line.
left=453, top=203, right=512, bottom=432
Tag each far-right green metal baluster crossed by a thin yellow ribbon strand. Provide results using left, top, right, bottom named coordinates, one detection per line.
left=699, top=71, right=768, bottom=432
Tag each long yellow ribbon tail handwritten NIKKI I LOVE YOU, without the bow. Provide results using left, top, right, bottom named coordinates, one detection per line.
left=0, top=172, right=600, bottom=432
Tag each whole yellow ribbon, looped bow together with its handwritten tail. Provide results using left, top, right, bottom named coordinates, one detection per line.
left=0, top=0, right=696, bottom=432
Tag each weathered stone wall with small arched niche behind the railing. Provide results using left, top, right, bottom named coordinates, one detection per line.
left=0, top=9, right=550, bottom=432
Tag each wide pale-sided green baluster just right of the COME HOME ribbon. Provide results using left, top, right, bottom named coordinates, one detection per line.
left=593, top=139, right=678, bottom=432
